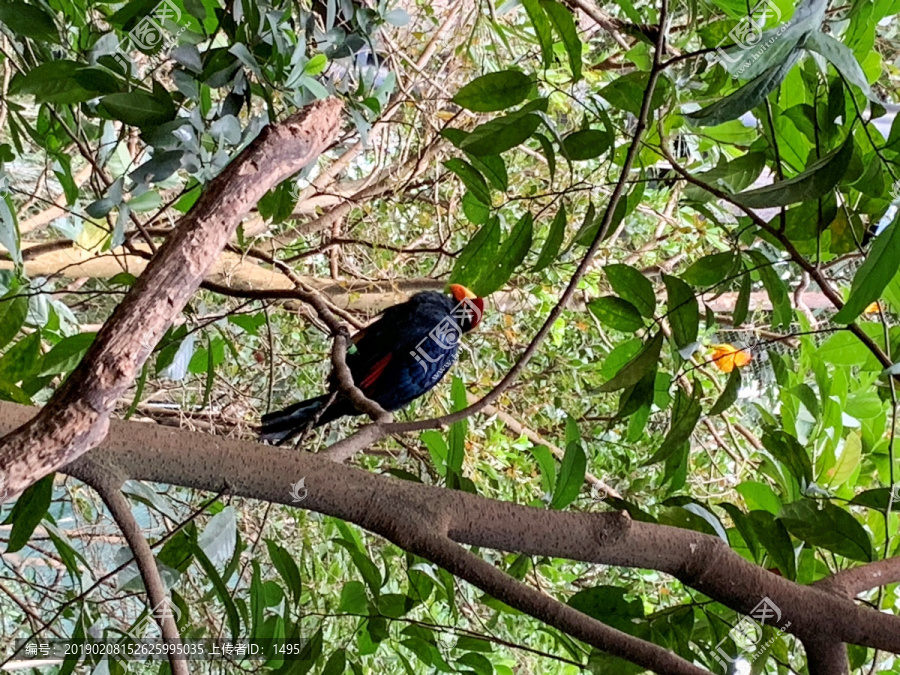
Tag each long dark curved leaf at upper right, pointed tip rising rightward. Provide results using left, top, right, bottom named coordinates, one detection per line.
left=733, top=135, right=853, bottom=209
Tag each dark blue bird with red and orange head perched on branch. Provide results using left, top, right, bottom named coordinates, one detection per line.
left=258, top=284, right=484, bottom=445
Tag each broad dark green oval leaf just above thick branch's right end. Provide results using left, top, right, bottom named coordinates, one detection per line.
left=779, top=499, right=873, bottom=562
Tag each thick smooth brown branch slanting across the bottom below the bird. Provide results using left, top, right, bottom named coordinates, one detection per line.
left=0, top=403, right=900, bottom=664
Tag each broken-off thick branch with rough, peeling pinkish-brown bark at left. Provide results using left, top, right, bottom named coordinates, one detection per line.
left=0, top=99, right=342, bottom=496
